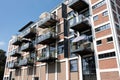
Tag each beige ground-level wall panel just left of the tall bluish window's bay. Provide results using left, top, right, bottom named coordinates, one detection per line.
left=58, top=62, right=66, bottom=80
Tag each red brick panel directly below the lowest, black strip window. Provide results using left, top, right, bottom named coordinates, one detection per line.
left=99, top=58, right=117, bottom=69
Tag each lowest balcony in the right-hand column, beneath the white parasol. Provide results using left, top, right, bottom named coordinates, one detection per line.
left=72, top=42, right=94, bottom=56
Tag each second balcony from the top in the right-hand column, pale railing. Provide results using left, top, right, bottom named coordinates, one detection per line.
left=69, top=15, right=91, bottom=32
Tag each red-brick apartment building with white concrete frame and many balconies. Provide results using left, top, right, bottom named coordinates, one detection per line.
left=3, top=0, right=120, bottom=80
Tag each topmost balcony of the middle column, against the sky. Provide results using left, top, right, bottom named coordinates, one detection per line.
left=38, top=12, right=57, bottom=28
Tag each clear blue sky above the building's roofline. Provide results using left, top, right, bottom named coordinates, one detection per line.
left=0, top=0, right=62, bottom=51
